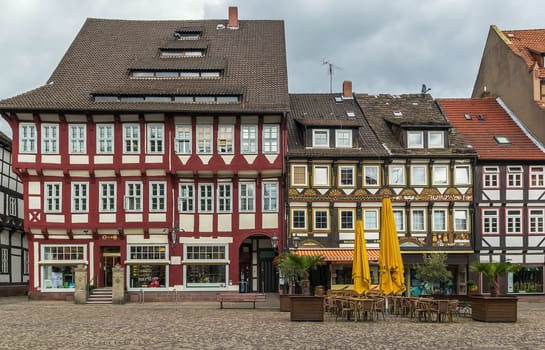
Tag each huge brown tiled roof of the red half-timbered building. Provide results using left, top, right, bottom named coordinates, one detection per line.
left=0, top=19, right=289, bottom=113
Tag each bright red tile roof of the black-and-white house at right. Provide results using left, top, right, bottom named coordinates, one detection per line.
left=438, top=98, right=545, bottom=160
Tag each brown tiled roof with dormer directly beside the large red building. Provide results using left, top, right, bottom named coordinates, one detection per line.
left=288, top=94, right=387, bottom=157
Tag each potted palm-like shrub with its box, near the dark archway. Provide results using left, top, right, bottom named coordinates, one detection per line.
left=276, top=253, right=324, bottom=321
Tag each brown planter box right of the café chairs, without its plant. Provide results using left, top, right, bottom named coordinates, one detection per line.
left=471, top=295, right=518, bottom=322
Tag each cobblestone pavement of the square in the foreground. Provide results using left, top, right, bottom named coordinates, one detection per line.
left=0, top=297, right=545, bottom=350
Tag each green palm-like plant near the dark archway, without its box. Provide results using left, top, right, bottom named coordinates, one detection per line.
left=276, top=253, right=324, bottom=295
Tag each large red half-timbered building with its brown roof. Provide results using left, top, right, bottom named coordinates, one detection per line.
left=0, top=8, right=289, bottom=298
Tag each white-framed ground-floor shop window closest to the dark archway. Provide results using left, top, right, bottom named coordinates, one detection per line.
left=183, top=243, right=225, bottom=289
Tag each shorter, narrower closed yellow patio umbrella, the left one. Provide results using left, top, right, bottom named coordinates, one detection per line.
left=352, top=220, right=371, bottom=295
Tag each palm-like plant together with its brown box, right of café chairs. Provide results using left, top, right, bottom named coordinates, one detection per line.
left=469, top=262, right=520, bottom=322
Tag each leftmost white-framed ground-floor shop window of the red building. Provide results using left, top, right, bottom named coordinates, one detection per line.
left=40, top=244, right=87, bottom=292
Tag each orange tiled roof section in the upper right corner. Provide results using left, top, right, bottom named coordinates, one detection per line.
left=501, top=29, right=545, bottom=72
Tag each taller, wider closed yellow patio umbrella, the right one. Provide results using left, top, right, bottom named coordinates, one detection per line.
left=378, top=198, right=405, bottom=295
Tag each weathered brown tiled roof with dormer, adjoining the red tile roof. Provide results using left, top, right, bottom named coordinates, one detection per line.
left=355, top=94, right=474, bottom=156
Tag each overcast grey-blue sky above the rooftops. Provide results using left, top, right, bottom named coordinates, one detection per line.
left=0, top=0, right=545, bottom=135
